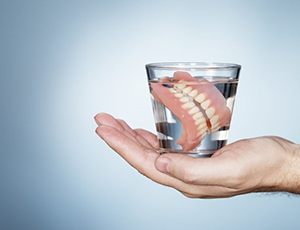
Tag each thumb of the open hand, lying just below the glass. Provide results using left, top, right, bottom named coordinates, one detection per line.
left=155, top=153, right=234, bottom=186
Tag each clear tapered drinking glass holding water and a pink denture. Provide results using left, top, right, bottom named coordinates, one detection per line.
left=146, top=62, right=241, bottom=157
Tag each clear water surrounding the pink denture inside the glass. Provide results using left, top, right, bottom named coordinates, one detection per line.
left=149, top=77, right=238, bottom=157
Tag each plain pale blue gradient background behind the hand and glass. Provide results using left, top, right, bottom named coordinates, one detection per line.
left=0, top=0, right=300, bottom=230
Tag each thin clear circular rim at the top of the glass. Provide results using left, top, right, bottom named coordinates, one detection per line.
left=146, top=62, right=242, bottom=70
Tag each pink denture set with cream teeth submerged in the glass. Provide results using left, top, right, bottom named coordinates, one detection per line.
left=151, top=71, right=231, bottom=151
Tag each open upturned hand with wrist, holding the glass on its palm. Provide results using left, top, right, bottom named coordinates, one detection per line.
left=95, top=113, right=300, bottom=198
